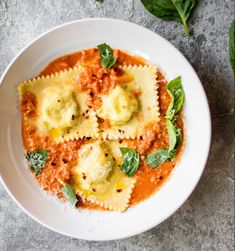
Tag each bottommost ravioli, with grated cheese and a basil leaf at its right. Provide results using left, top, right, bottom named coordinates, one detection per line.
left=71, top=141, right=135, bottom=211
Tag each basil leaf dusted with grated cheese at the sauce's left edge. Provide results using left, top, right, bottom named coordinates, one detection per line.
left=25, top=150, right=48, bottom=175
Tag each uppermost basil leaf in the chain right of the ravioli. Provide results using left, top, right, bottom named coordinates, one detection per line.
left=165, top=77, right=184, bottom=120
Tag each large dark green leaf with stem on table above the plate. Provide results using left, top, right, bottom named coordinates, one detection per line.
left=141, top=0, right=197, bottom=36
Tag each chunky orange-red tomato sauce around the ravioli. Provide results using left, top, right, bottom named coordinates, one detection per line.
left=21, top=48, right=184, bottom=209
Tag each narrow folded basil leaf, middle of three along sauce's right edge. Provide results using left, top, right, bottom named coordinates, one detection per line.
left=166, top=119, right=182, bottom=152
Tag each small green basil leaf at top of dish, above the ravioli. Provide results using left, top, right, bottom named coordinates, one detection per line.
left=98, top=44, right=116, bottom=68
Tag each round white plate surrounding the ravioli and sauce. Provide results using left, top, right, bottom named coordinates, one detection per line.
left=0, top=19, right=211, bottom=240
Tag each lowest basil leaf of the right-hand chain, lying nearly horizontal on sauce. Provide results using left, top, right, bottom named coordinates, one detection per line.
left=145, top=148, right=175, bottom=168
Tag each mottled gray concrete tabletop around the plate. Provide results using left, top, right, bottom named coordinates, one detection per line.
left=0, top=0, right=234, bottom=251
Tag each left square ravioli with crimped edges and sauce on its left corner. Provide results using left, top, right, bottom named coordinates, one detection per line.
left=18, top=66, right=99, bottom=142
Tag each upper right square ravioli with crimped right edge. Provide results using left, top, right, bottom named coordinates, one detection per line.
left=96, top=65, right=159, bottom=139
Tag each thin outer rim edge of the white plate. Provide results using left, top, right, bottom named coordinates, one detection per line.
left=0, top=18, right=212, bottom=241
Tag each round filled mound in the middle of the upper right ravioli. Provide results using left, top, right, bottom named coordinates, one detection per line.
left=97, top=85, right=138, bottom=125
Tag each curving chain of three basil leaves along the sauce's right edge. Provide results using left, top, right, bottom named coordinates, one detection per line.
left=145, top=77, right=184, bottom=168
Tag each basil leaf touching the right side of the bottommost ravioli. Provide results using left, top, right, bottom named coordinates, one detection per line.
left=120, top=147, right=140, bottom=177
